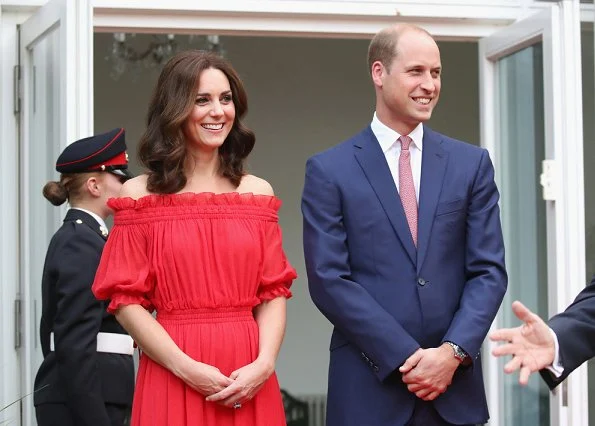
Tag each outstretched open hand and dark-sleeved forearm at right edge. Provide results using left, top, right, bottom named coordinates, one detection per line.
left=490, top=277, right=595, bottom=389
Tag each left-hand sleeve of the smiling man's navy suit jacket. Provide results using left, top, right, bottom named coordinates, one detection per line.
left=302, top=157, right=420, bottom=381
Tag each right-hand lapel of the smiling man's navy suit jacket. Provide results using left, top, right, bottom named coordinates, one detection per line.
left=417, top=126, right=448, bottom=273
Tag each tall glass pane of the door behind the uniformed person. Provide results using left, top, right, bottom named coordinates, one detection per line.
left=22, top=25, right=62, bottom=420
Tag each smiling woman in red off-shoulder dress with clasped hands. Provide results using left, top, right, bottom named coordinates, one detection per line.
left=93, top=51, right=296, bottom=426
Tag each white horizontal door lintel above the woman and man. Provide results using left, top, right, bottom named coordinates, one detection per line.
left=93, top=0, right=546, bottom=40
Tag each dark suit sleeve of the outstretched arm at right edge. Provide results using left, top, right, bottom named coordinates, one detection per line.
left=540, top=277, right=595, bottom=389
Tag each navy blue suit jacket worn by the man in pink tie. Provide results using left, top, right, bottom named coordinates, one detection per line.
left=302, top=127, right=507, bottom=426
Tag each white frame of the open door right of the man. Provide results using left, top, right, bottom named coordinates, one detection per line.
left=479, top=0, right=589, bottom=426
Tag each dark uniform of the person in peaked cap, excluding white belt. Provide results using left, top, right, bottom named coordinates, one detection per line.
left=34, top=209, right=134, bottom=425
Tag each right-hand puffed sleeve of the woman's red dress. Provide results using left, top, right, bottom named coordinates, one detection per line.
left=257, top=222, right=297, bottom=302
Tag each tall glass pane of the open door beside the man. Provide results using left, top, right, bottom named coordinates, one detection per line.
left=498, top=44, right=549, bottom=426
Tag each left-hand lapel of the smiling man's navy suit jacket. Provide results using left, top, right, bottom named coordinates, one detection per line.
left=354, top=126, right=416, bottom=264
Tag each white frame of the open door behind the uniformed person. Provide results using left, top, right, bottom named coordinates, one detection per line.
left=18, top=0, right=93, bottom=425
